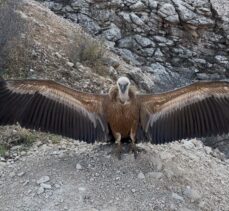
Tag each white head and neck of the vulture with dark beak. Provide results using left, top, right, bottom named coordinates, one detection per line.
left=117, top=76, right=130, bottom=102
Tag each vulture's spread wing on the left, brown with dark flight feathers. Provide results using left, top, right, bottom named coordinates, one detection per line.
left=0, top=80, right=108, bottom=142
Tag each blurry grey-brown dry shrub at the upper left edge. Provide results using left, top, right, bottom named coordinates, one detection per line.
left=0, top=0, right=31, bottom=77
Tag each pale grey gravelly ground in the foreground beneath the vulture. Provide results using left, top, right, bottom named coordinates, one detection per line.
left=0, top=128, right=229, bottom=211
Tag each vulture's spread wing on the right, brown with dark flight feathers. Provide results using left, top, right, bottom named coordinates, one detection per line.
left=138, top=81, right=229, bottom=144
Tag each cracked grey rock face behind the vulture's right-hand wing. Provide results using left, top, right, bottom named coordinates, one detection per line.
left=40, top=0, right=229, bottom=91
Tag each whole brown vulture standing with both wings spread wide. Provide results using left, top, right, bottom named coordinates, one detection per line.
left=0, top=77, right=229, bottom=156
